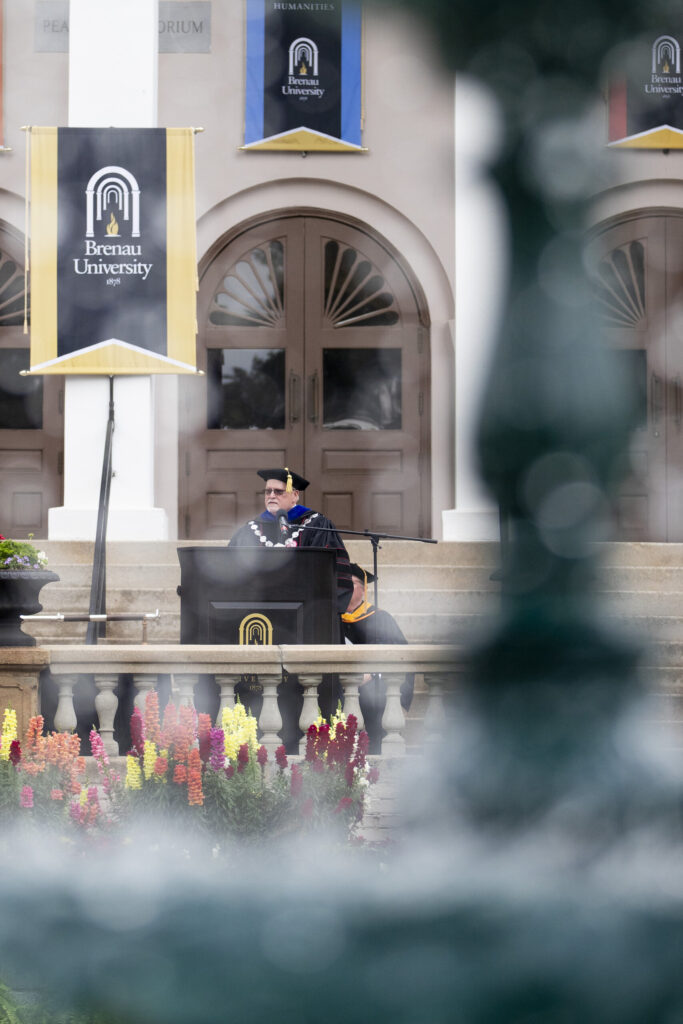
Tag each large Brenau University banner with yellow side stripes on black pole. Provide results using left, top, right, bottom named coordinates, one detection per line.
left=31, top=128, right=197, bottom=374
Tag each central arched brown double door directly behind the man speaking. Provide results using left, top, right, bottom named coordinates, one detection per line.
left=180, top=212, right=431, bottom=539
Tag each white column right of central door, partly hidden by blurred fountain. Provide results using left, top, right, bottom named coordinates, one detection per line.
left=442, top=76, right=507, bottom=541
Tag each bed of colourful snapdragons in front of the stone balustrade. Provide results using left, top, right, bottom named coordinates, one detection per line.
left=0, top=692, right=378, bottom=845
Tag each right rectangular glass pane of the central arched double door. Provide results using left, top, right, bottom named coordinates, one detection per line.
left=323, top=348, right=401, bottom=430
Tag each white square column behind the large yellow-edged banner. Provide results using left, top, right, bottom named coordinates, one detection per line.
left=48, top=0, right=177, bottom=540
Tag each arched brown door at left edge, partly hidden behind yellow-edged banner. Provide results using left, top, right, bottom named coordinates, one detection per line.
left=0, top=230, right=63, bottom=538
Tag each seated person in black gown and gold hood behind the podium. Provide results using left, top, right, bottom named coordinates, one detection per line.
left=342, top=563, right=415, bottom=754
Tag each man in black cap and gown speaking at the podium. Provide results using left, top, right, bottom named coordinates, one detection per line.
left=230, top=467, right=353, bottom=754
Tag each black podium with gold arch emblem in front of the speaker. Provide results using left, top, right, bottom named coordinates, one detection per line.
left=177, top=547, right=341, bottom=644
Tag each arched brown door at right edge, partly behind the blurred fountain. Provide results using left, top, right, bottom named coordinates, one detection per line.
left=589, top=211, right=683, bottom=541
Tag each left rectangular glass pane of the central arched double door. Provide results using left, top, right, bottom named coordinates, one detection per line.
left=207, top=348, right=285, bottom=430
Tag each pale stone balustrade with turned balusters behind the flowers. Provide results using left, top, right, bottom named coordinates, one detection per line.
left=13, top=644, right=463, bottom=756
